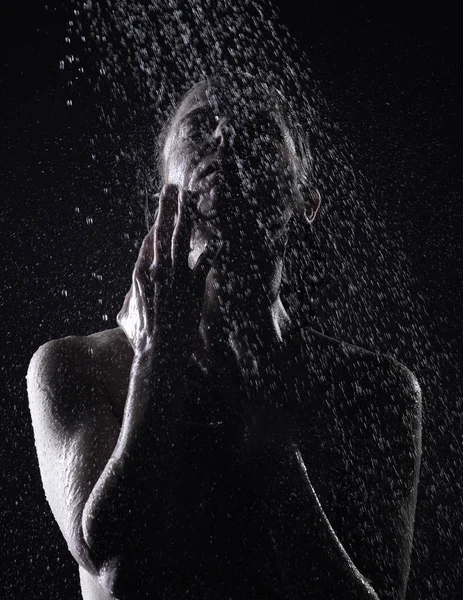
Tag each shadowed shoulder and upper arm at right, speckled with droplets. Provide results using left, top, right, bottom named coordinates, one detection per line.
left=284, top=329, right=421, bottom=598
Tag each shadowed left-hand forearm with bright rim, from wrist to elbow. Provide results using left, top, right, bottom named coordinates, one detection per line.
left=82, top=353, right=188, bottom=564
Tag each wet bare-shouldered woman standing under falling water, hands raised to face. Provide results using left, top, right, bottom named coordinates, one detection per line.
left=28, top=77, right=421, bottom=600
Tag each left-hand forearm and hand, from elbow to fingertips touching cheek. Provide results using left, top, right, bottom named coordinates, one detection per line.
left=82, top=184, right=223, bottom=564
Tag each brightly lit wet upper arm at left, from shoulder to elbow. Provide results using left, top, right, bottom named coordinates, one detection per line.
left=27, top=337, right=119, bottom=573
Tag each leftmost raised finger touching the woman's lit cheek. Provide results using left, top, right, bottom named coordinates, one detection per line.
left=154, top=184, right=178, bottom=267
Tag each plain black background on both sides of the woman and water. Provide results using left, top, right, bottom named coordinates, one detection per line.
left=0, top=0, right=463, bottom=600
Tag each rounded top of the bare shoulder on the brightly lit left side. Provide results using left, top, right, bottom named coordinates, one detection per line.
left=27, top=328, right=133, bottom=418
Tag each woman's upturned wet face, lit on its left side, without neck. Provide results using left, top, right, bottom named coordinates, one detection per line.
left=163, top=81, right=297, bottom=253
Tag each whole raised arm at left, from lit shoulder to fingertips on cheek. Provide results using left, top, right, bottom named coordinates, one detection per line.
left=27, top=186, right=227, bottom=593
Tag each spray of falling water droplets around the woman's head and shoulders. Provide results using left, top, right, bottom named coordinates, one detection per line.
left=12, top=0, right=462, bottom=598
